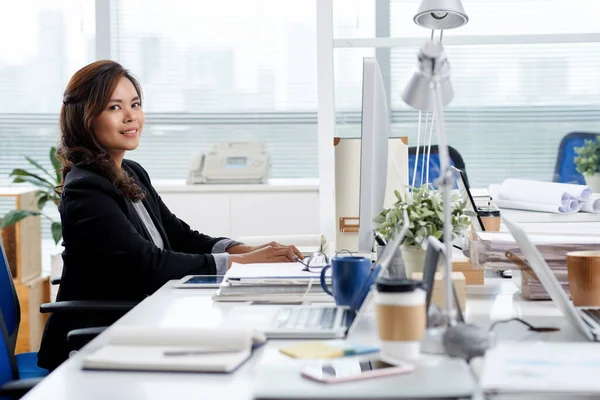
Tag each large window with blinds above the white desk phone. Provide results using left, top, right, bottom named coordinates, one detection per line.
left=111, top=0, right=318, bottom=179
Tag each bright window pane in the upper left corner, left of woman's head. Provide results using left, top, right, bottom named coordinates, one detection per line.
left=0, top=0, right=95, bottom=112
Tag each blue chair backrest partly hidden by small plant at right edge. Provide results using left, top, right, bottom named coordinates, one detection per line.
left=552, top=132, right=600, bottom=185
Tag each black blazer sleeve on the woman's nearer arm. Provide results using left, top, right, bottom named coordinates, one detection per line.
left=61, top=182, right=216, bottom=293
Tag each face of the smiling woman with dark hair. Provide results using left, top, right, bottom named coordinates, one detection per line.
left=92, top=77, right=144, bottom=165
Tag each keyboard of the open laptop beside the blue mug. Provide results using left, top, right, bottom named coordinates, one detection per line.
left=275, top=307, right=338, bottom=330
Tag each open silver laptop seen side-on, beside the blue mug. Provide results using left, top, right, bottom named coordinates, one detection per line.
left=225, top=210, right=409, bottom=339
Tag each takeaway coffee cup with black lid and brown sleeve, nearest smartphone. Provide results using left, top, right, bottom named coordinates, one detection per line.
left=375, top=278, right=427, bottom=360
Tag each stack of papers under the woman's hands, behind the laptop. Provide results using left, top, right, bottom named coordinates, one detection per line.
left=213, top=263, right=334, bottom=303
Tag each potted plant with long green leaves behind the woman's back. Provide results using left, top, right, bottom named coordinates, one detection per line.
left=0, top=147, right=62, bottom=296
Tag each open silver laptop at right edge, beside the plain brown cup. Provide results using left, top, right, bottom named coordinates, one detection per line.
left=502, top=217, right=600, bottom=341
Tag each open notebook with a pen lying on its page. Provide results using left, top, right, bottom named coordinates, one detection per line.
left=83, top=326, right=266, bottom=372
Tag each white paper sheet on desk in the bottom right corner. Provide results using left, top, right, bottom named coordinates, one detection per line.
left=480, top=342, right=600, bottom=394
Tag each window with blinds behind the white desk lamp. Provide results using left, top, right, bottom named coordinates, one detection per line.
left=334, top=0, right=600, bottom=187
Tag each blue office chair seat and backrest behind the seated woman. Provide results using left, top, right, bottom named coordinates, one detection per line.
left=0, top=240, right=48, bottom=378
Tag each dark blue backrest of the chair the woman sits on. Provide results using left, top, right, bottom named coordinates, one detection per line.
left=0, top=238, right=21, bottom=354
